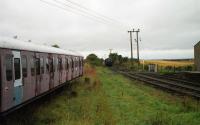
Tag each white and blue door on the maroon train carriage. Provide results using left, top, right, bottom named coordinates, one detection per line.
left=12, top=51, right=23, bottom=105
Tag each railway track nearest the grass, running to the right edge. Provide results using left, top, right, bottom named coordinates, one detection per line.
left=118, top=71, right=200, bottom=99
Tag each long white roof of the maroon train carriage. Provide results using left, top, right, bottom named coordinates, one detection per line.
left=0, top=37, right=82, bottom=56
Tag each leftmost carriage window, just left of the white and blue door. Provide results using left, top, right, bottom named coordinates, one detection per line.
left=5, top=55, right=13, bottom=81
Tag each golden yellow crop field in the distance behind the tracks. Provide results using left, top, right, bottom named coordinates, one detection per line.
left=141, top=60, right=194, bottom=67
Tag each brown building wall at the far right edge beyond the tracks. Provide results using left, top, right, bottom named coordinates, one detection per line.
left=194, top=42, right=200, bottom=71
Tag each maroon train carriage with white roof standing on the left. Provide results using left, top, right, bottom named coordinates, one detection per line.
left=0, top=38, right=83, bottom=114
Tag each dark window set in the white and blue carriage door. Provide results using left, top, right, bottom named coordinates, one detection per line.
left=14, top=58, right=21, bottom=80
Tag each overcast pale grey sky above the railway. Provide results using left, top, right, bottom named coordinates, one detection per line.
left=0, top=0, right=200, bottom=59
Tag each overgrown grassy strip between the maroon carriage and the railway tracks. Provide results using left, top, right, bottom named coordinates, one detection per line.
left=1, top=65, right=200, bottom=125
